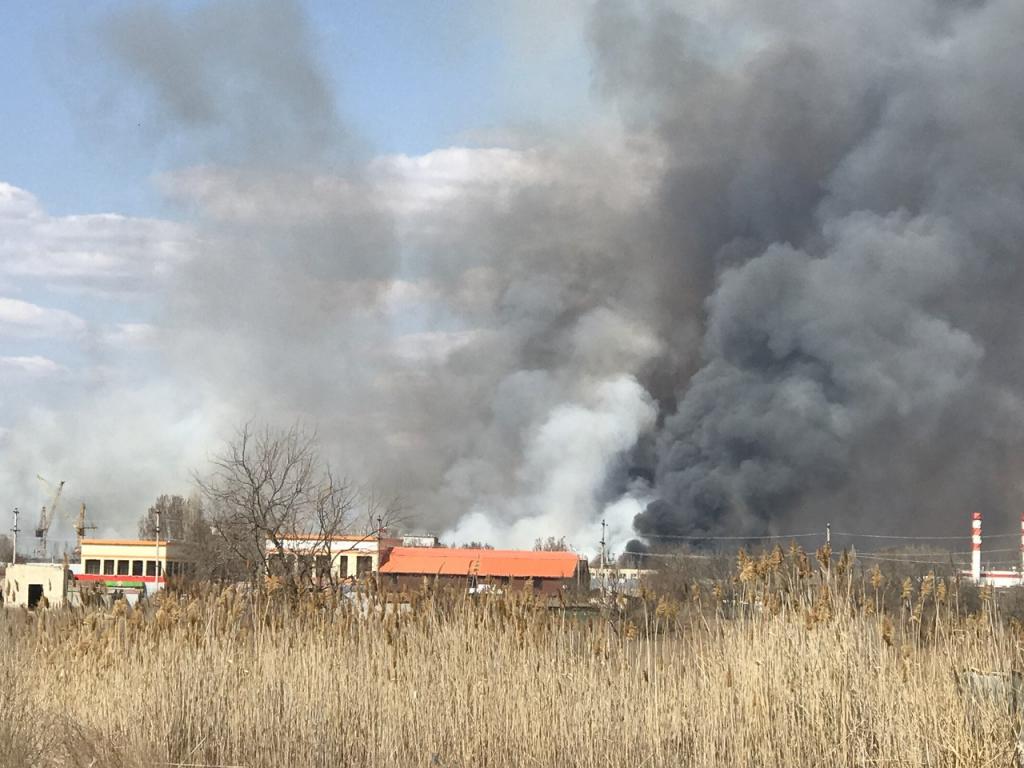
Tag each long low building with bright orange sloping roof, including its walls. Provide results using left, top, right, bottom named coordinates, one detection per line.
left=380, top=547, right=590, bottom=595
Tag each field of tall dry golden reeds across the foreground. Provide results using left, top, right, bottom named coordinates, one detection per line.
left=0, top=551, right=1019, bottom=768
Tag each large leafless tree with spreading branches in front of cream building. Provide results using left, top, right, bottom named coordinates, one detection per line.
left=196, top=423, right=357, bottom=579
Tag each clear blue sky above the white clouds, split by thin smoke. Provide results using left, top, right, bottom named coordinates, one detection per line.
left=0, top=0, right=591, bottom=216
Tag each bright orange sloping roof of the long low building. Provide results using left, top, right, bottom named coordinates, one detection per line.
left=380, top=547, right=580, bottom=579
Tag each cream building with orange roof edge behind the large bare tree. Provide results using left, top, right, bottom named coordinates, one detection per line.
left=266, top=532, right=400, bottom=582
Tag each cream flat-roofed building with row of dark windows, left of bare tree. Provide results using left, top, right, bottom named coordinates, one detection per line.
left=75, top=539, right=193, bottom=588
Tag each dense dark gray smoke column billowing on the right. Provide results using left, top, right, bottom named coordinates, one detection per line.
left=595, top=2, right=1024, bottom=535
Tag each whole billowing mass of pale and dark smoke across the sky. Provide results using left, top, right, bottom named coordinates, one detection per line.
left=22, top=0, right=1024, bottom=549
